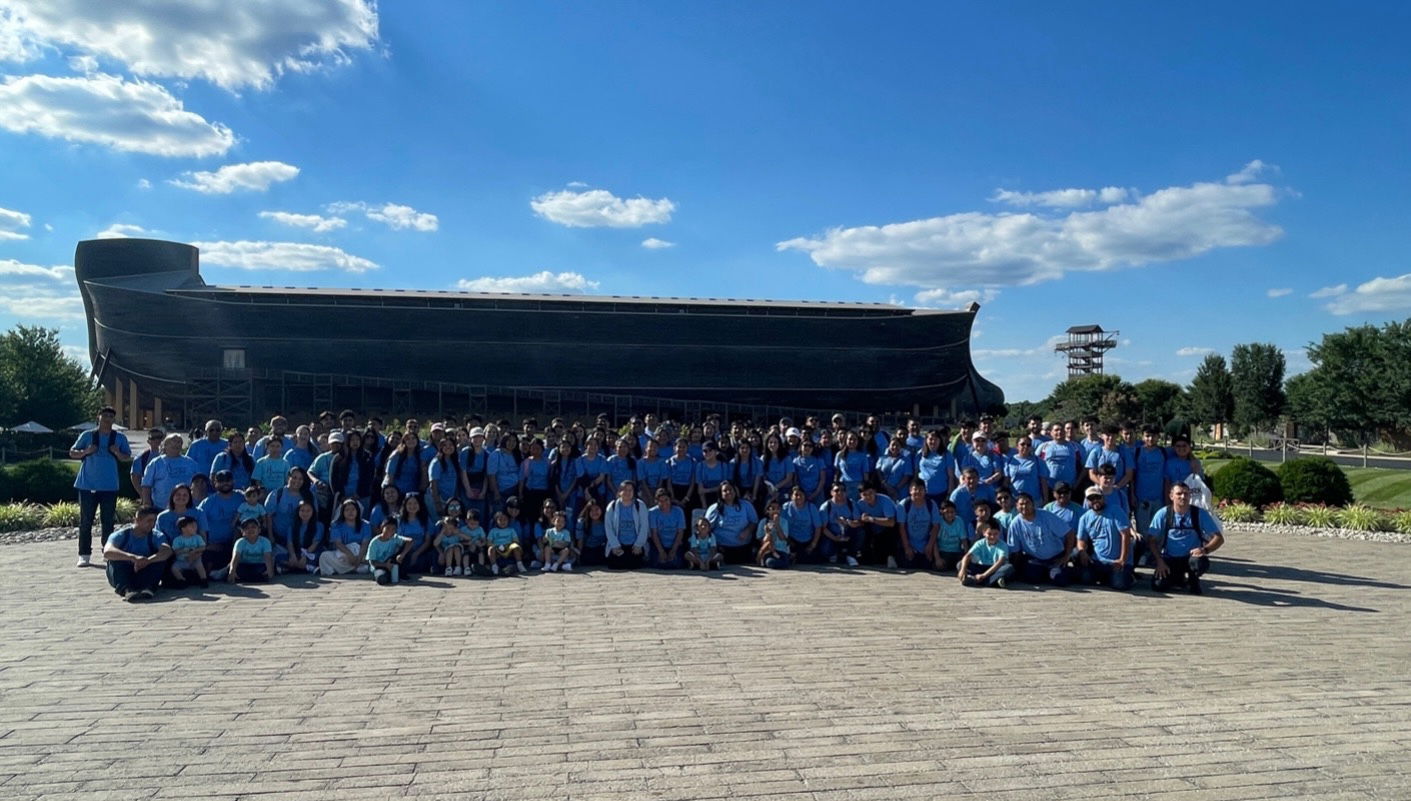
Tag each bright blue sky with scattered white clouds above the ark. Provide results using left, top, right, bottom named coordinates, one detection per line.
left=0, top=0, right=1411, bottom=401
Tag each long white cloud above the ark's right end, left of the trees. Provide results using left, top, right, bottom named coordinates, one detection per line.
left=776, top=165, right=1283, bottom=289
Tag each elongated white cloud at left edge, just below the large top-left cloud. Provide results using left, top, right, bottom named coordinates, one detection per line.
left=0, top=75, right=236, bottom=157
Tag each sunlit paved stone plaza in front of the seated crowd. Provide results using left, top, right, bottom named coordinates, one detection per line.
left=0, top=533, right=1411, bottom=801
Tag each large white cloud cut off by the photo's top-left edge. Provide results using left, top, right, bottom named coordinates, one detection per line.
left=0, top=0, right=378, bottom=90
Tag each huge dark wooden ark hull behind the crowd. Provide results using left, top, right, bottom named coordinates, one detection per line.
left=75, top=240, right=1003, bottom=417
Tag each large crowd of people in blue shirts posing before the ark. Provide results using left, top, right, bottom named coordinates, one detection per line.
left=69, top=409, right=1223, bottom=601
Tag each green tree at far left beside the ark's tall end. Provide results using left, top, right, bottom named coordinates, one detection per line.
left=0, top=326, right=100, bottom=429
